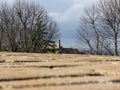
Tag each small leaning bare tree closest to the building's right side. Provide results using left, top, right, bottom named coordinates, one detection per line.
left=77, top=16, right=94, bottom=54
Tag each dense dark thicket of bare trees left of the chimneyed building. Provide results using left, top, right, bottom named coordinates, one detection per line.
left=0, top=0, right=59, bottom=52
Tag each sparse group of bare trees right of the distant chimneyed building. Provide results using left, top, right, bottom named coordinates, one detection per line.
left=77, top=0, right=120, bottom=56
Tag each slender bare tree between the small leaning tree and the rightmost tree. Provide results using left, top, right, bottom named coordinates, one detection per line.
left=77, top=5, right=100, bottom=54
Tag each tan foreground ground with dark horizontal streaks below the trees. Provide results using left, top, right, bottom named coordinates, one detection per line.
left=0, top=52, right=120, bottom=90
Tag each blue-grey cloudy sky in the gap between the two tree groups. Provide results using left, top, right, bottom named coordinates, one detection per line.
left=0, top=0, right=97, bottom=47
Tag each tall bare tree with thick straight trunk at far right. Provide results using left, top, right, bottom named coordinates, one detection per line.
left=98, top=0, right=120, bottom=55
